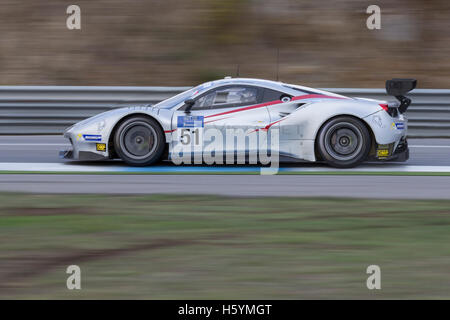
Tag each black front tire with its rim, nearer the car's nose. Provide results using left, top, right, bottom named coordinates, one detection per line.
left=114, top=116, right=165, bottom=167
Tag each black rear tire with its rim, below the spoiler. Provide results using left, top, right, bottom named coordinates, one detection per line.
left=316, top=116, right=371, bottom=168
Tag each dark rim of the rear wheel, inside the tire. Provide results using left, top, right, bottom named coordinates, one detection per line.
left=325, top=122, right=363, bottom=161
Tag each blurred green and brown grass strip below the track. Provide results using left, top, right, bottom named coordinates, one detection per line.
left=0, top=193, right=450, bottom=299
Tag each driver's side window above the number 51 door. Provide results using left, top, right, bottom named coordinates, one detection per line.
left=192, top=86, right=259, bottom=110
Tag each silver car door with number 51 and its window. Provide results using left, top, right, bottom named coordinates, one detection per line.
left=172, top=85, right=270, bottom=162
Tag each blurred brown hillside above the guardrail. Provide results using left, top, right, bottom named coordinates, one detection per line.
left=0, top=0, right=450, bottom=88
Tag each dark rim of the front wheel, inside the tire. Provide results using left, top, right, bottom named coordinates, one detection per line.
left=120, top=121, right=158, bottom=160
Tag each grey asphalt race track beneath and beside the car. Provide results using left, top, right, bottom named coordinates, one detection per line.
left=0, top=136, right=450, bottom=199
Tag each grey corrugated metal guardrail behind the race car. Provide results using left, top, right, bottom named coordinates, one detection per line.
left=0, top=86, right=450, bottom=138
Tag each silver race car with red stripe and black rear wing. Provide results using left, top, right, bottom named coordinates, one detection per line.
left=60, top=78, right=416, bottom=168
